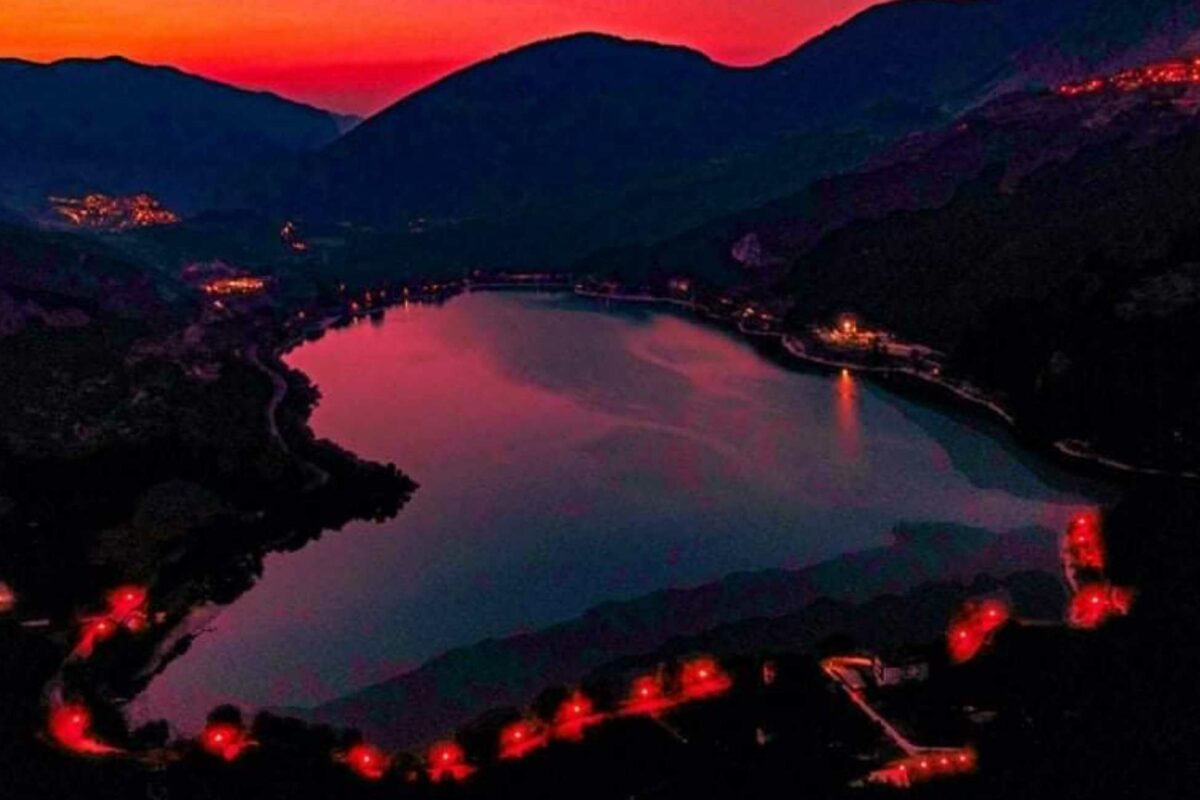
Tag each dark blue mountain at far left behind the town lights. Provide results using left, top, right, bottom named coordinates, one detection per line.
left=0, top=58, right=352, bottom=212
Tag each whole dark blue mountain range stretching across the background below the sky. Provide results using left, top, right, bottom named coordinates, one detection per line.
left=0, top=0, right=1198, bottom=271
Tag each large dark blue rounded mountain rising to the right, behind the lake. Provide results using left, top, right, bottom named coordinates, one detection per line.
left=227, top=0, right=1193, bottom=272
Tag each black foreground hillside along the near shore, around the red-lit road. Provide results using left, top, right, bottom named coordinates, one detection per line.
left=0, top=483, right=1200, bottom=800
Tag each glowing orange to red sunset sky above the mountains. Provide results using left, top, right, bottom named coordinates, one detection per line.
left=0, top=0, right=878, bottom=114
